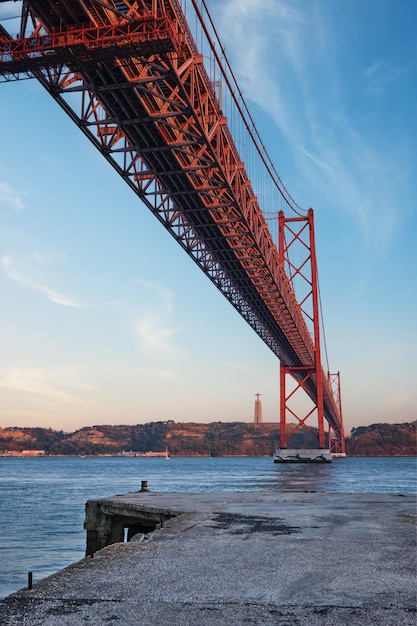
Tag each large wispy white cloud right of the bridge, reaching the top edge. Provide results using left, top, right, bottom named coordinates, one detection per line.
left=221, top=0, right=411, bottom=249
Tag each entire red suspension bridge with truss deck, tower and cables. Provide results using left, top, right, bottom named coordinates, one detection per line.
left=0, top=0, right=345, bottom=453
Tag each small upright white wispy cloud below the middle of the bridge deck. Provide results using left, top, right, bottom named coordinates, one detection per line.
left=133, top=280, right=179, bottom=353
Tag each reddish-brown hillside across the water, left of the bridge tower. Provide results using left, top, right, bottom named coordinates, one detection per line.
left=0, top=421, right=315, bottom=456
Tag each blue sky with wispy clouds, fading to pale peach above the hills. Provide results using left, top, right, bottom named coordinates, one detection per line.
left=0, top=0, right=417, bottom=431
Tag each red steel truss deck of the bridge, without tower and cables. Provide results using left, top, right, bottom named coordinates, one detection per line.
left=0, top=0, right=344, bottom=451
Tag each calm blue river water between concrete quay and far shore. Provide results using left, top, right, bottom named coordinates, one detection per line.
left=0, top=457, right=417, bottom=598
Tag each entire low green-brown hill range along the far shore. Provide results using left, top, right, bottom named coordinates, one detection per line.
left=0, top=421, right=417, bottom=456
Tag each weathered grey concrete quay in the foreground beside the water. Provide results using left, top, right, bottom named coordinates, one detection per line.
left=0, top=492, right=417, bottom=626
